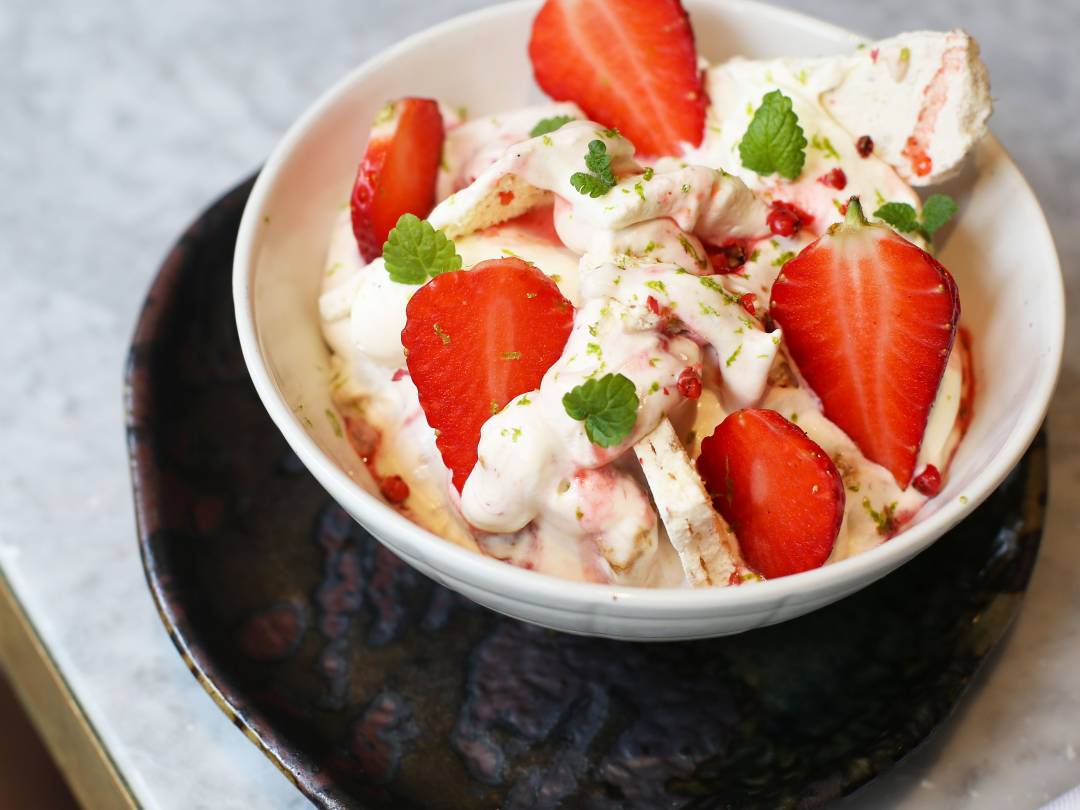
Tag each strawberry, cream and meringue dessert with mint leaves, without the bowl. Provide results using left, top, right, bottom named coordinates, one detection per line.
left=319, top=0, right=990, bottom=588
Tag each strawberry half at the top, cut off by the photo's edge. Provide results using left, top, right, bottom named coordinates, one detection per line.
left=529, top=0, right=706, bottom=154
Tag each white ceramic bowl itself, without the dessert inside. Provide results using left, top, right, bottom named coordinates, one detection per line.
left=233, top=0, right=1065, bottom=640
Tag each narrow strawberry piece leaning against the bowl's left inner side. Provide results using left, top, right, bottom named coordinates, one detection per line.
left=350, top=98, right=444, bottom=261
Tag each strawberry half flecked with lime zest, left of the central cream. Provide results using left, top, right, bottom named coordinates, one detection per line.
left=402, top=258, right=573, bottom=490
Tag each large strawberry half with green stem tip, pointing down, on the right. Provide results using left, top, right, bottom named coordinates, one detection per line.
left=770, top=198, right=960, bottom=488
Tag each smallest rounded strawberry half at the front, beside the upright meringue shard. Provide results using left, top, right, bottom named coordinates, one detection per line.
left=698, top=408, right=845, bottom=579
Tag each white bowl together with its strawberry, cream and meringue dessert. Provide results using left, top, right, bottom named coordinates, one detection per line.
left=235, top=2, right=1063, bottom=639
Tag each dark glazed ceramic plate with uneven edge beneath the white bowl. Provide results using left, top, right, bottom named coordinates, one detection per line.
left=127, top=181, right=1047, bottom=810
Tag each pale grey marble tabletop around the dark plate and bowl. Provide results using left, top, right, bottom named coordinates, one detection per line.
left=0, top=0, right=1080, bottom=809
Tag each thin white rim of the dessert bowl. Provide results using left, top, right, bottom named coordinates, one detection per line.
left=232, top=0, right=1065, bottom=618
